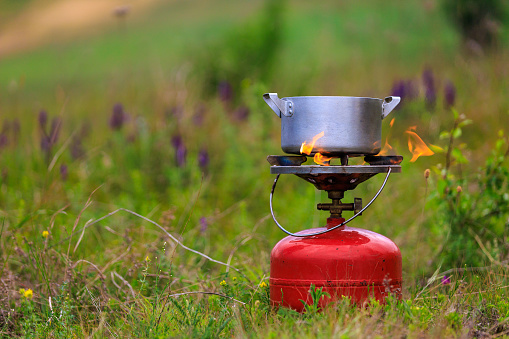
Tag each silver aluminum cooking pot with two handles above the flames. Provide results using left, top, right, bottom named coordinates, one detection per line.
left=263, top=93, right=400, bottom=156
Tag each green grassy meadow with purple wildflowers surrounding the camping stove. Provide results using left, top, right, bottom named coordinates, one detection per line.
left=0, top=0, right=509, bottom=338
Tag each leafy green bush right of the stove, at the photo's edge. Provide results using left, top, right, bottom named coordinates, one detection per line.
left=431, top=110, right=509, bottom=268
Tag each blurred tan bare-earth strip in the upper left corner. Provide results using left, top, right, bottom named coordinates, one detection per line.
left=0, top=0, right=158, bottom=58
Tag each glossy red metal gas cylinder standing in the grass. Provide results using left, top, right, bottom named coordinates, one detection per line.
left=270, top=218, right=402, bottom=312
